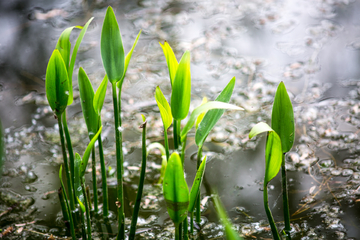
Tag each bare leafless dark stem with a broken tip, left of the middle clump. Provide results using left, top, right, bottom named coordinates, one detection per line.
left=129, top=121, right=146, bottom=240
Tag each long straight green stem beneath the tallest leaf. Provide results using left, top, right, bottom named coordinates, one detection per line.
left=111, top=81, right=125, bottom=240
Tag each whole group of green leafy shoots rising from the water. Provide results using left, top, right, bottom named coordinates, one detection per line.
left=46, top=3, right=294, bottom=239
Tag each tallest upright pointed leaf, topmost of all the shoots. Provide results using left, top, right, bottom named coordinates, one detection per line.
left=100, top=7, right=125, bottom=83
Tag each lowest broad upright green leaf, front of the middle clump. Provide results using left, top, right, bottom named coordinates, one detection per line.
left=163, top=152, right=189, bottom=224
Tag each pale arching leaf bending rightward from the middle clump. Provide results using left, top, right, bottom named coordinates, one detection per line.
left=181, top=101, right=243, bottom=141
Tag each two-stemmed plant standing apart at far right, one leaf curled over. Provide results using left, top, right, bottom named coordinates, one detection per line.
left=249, top=82, right=295, bottom=239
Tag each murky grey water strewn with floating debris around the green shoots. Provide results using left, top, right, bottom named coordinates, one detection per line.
left=0, top=0, right=360, bottom=239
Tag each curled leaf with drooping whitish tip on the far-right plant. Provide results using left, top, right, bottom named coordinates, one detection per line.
left=249, top=122, right=282, bottom=184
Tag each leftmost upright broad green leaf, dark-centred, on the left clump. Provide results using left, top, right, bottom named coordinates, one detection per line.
left=45, top=49, right=69, bottom=116
